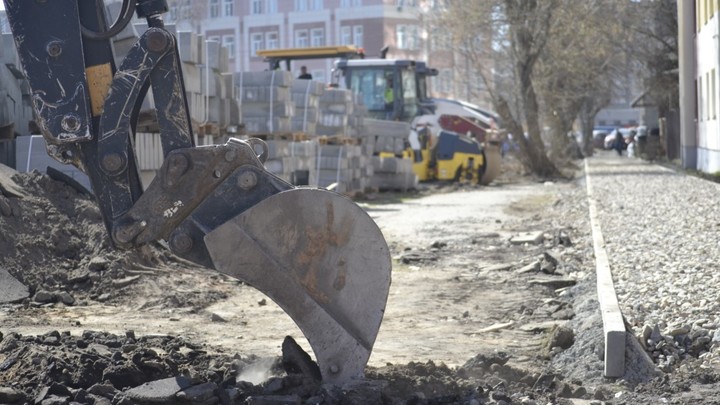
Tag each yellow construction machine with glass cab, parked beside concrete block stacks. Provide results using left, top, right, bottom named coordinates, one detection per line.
left=335, top=57, right=500, bottom=184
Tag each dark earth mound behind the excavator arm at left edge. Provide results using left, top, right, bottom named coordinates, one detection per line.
left=0, top=167, right=214, bottom=305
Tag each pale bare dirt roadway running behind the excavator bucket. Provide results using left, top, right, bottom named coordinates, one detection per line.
left=0, top=180, right=572, bottom=366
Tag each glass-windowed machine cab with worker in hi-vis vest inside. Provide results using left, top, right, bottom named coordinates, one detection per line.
left=334, top=59, right=420, bottom=122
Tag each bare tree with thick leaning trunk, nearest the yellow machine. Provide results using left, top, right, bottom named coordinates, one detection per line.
left=438, top=0, right=560, bottom=177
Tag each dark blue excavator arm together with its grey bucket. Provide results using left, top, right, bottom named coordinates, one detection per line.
left=4, top=0, right=391, bottom=384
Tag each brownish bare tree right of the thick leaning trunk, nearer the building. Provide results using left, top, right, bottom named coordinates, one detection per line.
left=536, top=0, right=628, bottom=159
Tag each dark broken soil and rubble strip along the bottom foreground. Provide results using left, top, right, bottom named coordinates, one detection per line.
left=0, top=331, right=587, bottom=405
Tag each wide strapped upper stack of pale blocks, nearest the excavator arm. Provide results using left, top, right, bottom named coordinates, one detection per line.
left=234, top=70, right=295, bottom=135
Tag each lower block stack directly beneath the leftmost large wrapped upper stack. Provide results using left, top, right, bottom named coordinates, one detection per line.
left=265, top=140, right=318, bottom=186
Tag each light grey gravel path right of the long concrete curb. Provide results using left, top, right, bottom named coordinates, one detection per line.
left=590, top=155, right=720, bottom=371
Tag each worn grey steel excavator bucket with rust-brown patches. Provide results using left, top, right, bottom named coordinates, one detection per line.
left=205, top=188, right=391, bottom=384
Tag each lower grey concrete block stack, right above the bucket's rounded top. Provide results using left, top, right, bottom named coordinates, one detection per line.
left=316, top=145, right=369, bottom=194
